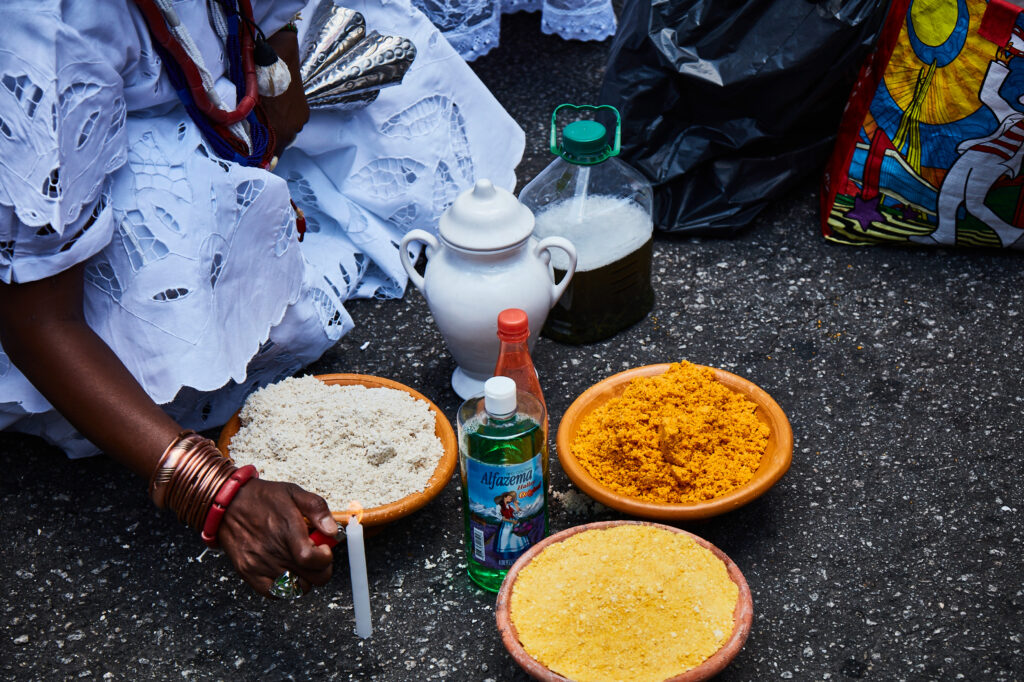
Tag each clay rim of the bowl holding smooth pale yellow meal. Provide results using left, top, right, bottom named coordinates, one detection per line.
left=496, top=521, right=754, bottom=682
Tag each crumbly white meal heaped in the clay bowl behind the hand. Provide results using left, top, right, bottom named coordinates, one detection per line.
left=230, top=376, right=442, bottom=511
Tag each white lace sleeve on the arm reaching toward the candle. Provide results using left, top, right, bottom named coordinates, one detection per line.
left=0, top=5, right=125, bottom=283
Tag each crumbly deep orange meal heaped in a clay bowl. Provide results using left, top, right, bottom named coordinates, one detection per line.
left=572, top=363, right=769, bottom=504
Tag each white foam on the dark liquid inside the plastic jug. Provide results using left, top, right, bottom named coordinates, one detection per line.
left=534, top=195, right=651, bottom=272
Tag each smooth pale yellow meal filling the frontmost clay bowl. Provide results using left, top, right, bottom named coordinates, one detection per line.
left=509, top=524, right=739, bottom=682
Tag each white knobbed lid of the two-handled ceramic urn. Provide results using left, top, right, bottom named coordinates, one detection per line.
left=438, top=179, right=534, bottom=251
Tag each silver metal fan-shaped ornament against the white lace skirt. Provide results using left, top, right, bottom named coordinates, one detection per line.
left=299, top=0, right=416, bottom=109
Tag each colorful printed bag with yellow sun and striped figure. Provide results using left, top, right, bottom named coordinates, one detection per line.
left=821, top=0, right=1024, bottom=249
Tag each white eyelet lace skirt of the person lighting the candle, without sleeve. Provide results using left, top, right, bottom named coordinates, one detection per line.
left=0, top=0, right=523, bottom=457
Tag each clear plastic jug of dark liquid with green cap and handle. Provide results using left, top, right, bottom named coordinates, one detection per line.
left=519, top=104, right=654, bottom=344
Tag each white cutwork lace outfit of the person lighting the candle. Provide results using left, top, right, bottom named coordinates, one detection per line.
left=0, top=0, right=523, bottom=456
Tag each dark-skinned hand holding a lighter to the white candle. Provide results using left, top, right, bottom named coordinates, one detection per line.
left=217, top=478, right=338, bottom=596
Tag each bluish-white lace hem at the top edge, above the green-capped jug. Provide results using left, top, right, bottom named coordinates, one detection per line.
left=413, top=0, right=616, bottom=61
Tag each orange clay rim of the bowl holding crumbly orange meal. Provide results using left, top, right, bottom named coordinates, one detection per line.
left=556, top=364, right=793, bottom=521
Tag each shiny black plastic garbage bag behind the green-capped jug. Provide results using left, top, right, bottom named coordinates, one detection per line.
left=600, top=0, right=889, bottom=235
